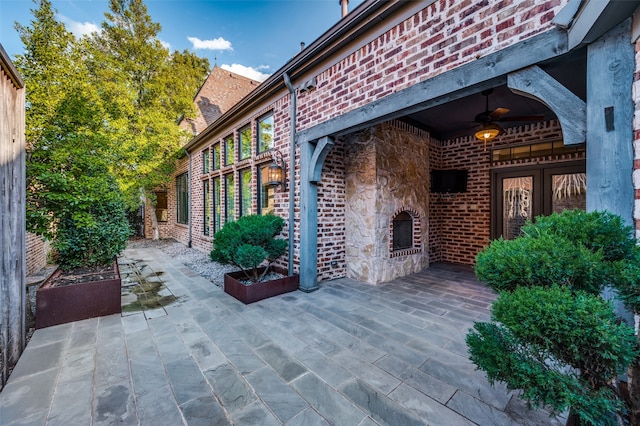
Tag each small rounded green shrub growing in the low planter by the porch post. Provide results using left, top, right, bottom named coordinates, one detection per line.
left=211, top=214, right=288, bottom=282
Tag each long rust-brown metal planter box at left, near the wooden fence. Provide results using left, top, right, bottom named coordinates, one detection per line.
left=36, top=261, right=121, bottom=328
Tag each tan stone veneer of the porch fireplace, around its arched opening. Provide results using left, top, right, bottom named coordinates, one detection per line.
left=345, top=122, right=430, bottom=284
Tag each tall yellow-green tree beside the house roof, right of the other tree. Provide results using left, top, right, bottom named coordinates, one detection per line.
left=90, top=0, right=209, bottom=238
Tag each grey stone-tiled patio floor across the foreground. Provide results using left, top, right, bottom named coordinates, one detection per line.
left=0, top=249, right=564, bottom=426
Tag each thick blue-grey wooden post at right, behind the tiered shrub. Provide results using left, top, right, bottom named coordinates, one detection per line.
left=587, top=19, right=635, bottom=226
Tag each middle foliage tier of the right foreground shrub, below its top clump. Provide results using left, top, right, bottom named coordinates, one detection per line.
left=475, top=233, right=606, bottom=293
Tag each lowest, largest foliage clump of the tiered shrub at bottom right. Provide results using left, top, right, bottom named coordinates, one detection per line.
left=466, top=286, right=638, bottom=425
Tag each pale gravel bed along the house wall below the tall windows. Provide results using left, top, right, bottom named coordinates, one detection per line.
left=127, top=238, right=237, bottom=287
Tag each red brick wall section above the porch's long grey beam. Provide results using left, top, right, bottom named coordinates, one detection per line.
left=298, top=0, right=567, bottom=129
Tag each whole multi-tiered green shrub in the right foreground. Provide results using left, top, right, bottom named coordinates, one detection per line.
left=467, top=210, right=640, bottom=425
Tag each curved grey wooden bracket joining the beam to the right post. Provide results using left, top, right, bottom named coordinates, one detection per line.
left=507, top=65, right=587, bottom=145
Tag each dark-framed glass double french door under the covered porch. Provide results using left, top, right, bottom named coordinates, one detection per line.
left=491, top=162, right=587, bottom=239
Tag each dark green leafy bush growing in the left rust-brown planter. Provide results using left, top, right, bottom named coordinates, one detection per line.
left=53, top=181, right=131, bottom=270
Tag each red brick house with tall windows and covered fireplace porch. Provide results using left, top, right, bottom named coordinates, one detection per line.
left=152, top=0, right=640, bottom=291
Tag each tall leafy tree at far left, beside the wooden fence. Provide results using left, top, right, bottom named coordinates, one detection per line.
left=15, top=0, right=117, bottom=238
